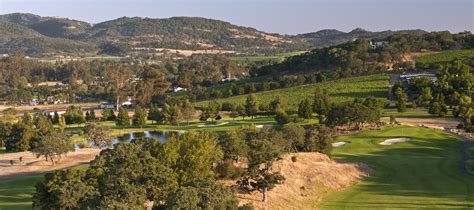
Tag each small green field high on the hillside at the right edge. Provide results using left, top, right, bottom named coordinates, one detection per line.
left=413, top=49, right=474, bottom=68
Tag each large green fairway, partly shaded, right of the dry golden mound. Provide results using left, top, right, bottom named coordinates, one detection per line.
left=319, top=127, right=474, bottom=209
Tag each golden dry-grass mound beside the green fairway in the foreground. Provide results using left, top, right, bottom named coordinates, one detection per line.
left=238, top=153, right=370, bottom=209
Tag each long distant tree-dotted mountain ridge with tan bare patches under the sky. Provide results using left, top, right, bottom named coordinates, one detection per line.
left=0, top=13, right=434, bottom=55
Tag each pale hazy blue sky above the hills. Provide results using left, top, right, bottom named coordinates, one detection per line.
left=0, top=0, right=474, bottom=34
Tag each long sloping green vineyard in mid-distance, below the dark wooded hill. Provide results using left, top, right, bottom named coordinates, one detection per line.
left=196, top=74, right=389, bottom=110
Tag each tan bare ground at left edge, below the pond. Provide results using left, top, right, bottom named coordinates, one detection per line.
left=0, top=149, right=100, bottom=180
